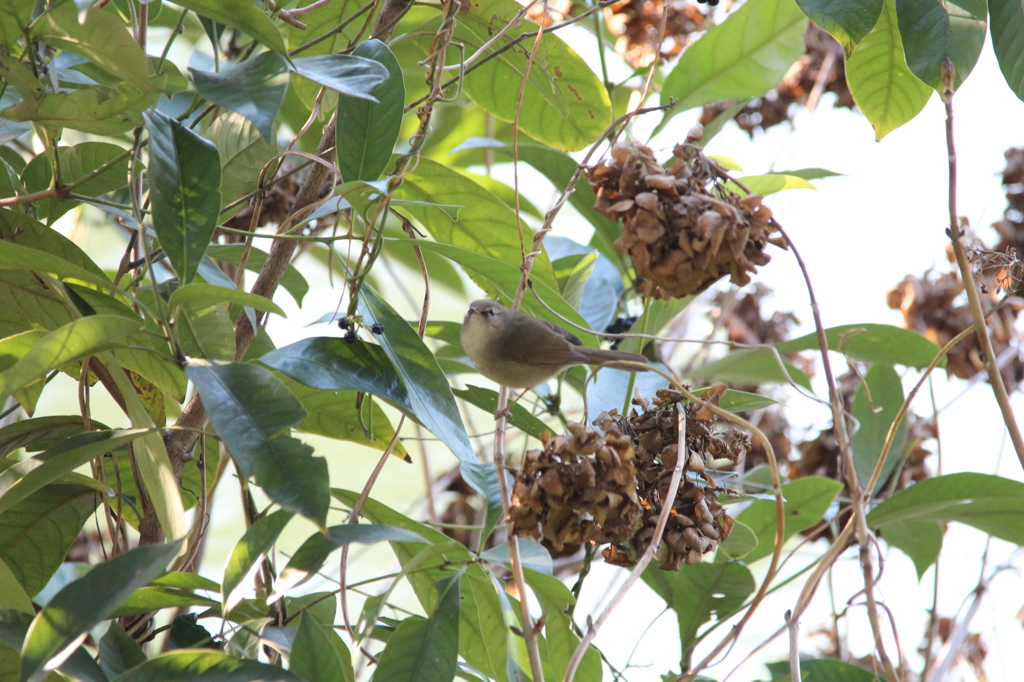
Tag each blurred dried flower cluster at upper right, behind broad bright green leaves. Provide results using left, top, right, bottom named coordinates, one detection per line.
left=700, top=24, right=854, bottom=137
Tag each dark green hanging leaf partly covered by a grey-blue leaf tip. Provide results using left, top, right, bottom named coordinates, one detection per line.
left=337, top=40, right=406, bottom=181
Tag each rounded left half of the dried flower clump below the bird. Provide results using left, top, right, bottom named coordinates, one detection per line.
left=509, top=424, right=640, bottom=550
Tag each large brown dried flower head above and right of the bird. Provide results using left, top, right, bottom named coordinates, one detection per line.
left=587, top=135, right=775, bottom=299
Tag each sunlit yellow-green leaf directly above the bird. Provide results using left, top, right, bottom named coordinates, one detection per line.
left=394, top=159, right=557, bottom=288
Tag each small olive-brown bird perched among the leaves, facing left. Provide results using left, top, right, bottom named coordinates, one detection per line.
left=461, top=300, right=647, bottom=388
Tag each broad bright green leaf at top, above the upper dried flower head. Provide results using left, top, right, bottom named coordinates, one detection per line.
left=655, top=0, right=807, bottom=131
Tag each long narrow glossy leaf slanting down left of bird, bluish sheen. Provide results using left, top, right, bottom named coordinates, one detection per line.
left=359, top=284, right=476, bottom=462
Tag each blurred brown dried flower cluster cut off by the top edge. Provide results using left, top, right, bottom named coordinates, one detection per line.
left=604, top=0, right=711, bottom=69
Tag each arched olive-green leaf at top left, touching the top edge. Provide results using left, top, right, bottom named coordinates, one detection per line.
left=32, top=4, right=152, bottom=90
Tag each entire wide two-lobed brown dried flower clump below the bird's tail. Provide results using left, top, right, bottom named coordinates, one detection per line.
left=509, top=386, right=750, bottom=570
